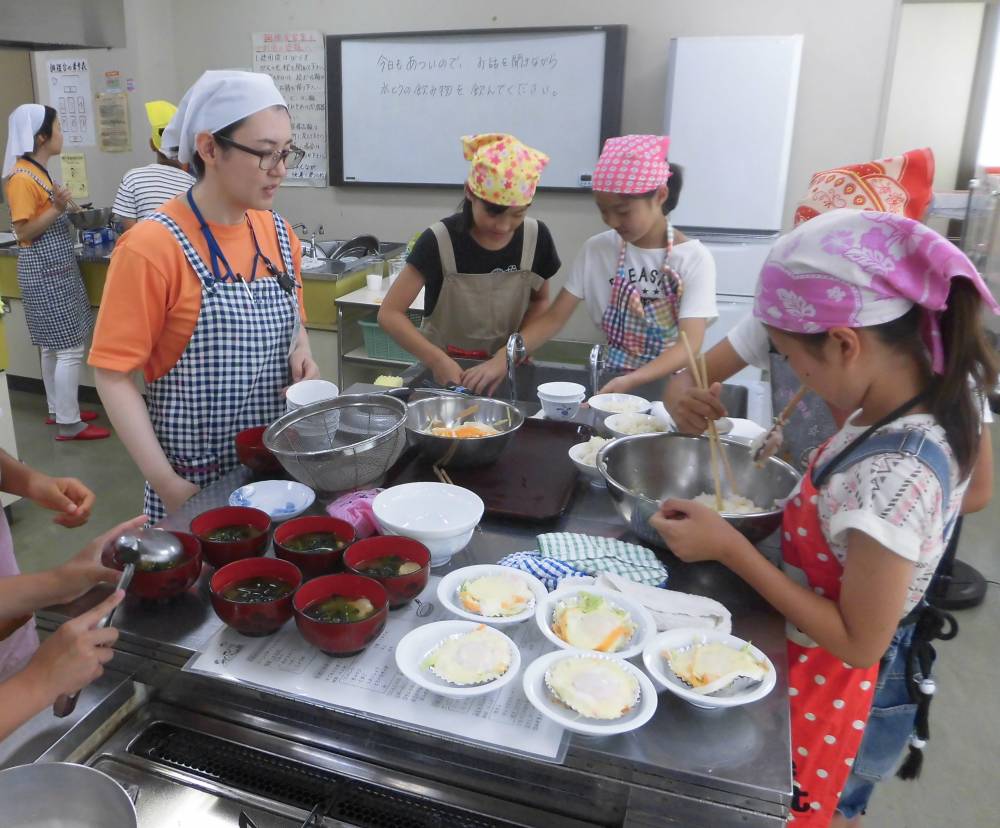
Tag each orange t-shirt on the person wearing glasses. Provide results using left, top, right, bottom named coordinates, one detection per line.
left=87, top=196, right=305, bottom=382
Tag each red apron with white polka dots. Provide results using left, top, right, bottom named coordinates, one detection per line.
left=781, top=460, right=878, bottom=828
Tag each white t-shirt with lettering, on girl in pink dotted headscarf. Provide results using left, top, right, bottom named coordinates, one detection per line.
left=566, top=230, right=719, bottom=327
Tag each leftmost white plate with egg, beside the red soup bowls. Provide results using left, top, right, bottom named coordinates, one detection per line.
left=396, top=620, right=521, bottom=699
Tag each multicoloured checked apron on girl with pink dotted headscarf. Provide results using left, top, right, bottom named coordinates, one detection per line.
left=601, top=222, right=683, bottom=371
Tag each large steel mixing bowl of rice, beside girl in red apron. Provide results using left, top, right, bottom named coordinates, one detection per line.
left=597, top=433, right=800, bottom=547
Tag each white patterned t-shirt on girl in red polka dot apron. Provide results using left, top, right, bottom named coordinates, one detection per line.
left=794, top=414, right=969, bottom=617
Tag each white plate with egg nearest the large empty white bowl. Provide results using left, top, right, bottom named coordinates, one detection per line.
left=438, top=564, right=549, bottom=627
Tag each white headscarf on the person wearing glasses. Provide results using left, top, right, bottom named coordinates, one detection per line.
left=161, top=69, right=288, bottom=164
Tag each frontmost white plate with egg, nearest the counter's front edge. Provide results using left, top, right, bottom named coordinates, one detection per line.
left=523, top=650, right=656, bottom=736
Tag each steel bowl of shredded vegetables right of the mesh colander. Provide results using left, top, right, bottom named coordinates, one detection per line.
left=406, top=395, right=524, bottom=469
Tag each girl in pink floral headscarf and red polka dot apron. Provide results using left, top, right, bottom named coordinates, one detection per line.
left=653, top=210, right=1000, bottom=826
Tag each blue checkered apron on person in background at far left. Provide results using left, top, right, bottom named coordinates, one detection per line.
left=12, top=168, right=94, bottom=350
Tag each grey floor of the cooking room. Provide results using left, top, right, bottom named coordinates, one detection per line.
left=11, top=392, right=1000, bottom=828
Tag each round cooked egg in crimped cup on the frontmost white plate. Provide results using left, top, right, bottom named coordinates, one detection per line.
left=545, top=656, right=640, bottom=719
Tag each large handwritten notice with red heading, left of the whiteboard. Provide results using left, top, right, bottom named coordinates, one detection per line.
left=253, top=31, right=329, bottom=187
